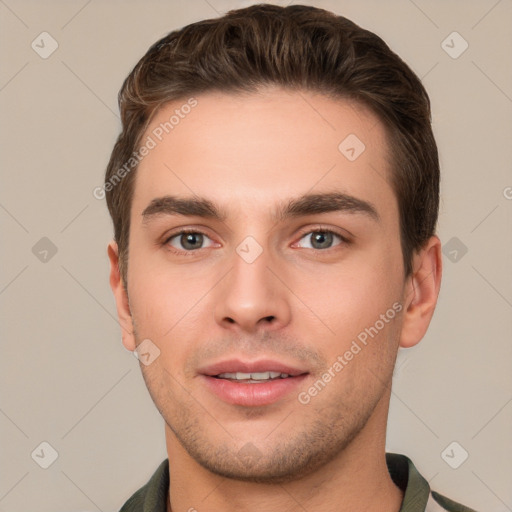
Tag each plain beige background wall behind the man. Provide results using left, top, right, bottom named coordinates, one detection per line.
left=0, top=0, right=512, bottom=512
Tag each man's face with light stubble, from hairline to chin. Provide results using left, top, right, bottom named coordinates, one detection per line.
left=110, top=89, right=406, bottom=483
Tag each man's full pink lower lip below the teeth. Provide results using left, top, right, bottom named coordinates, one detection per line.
left=201, top=374, right=307, bottom=407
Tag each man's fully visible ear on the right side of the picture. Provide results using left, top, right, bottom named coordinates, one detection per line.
left=400, top=236, right=442, bottom=348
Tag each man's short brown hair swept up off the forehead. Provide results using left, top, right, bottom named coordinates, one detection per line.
left=105, top=4, right=439, bottom=286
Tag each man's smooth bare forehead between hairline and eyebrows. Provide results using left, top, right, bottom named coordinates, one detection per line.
left=132, top=88, right=396, bottom=222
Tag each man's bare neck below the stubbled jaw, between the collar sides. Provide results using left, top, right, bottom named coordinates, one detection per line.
left=166, top=398, right=403, bottom=512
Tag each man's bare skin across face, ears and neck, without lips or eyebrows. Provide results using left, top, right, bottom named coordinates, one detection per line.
left=109, top=88, right=441, bottom=511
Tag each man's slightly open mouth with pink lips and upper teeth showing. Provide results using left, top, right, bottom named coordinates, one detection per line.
left=199, top=360, right=309, bottom=407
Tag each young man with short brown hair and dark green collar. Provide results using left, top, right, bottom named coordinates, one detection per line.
left=105, top=4, right=480, bottom=512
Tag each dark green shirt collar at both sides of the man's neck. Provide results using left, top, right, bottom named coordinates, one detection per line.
left=119, top=453, right=475, bottom=512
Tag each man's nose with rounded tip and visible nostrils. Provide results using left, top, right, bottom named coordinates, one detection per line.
left=214, top=246, right=291, bottom=333
